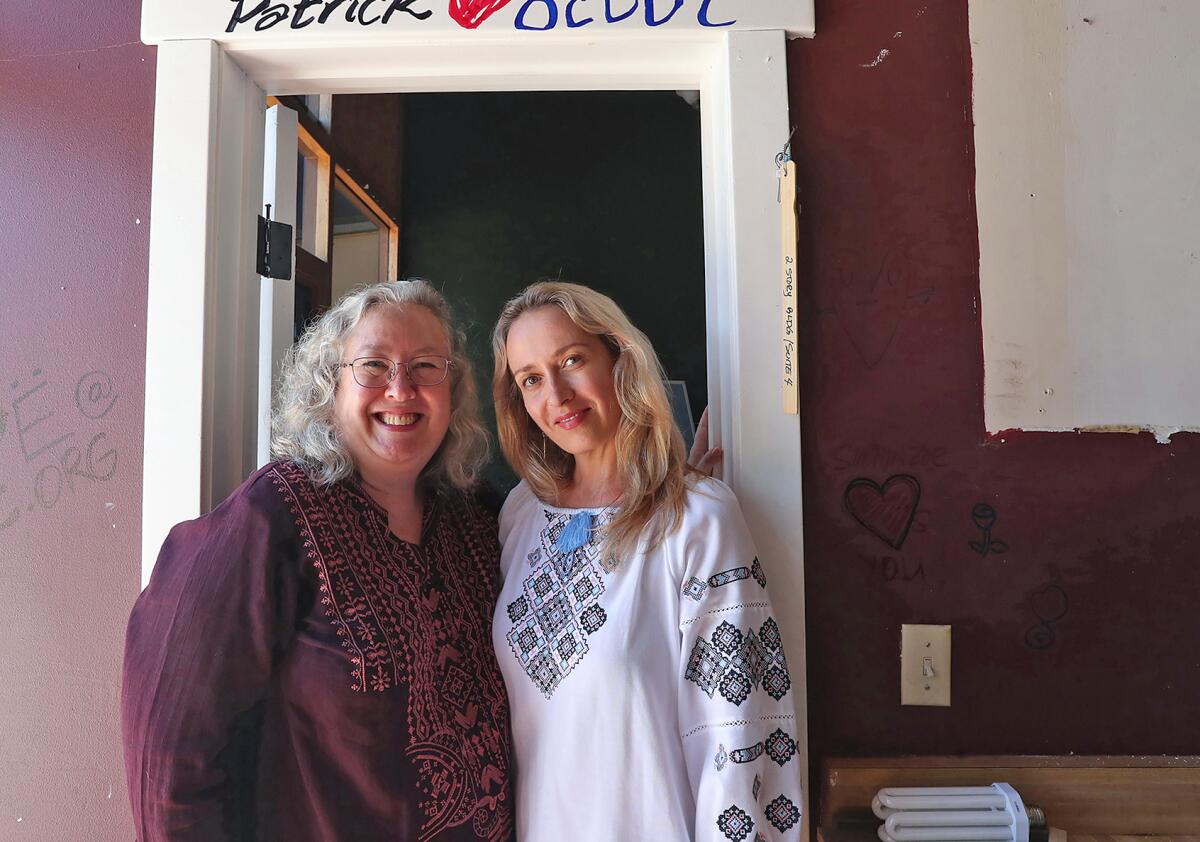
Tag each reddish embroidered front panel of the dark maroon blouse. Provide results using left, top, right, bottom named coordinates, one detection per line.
left=271, top=463, right=512, bottom=842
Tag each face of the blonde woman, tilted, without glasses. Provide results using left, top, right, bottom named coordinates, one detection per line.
left=505, top=306, right=620, bottom=474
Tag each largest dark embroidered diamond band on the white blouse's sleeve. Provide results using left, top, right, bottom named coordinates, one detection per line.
left=684, top=617, right=792, bottom=706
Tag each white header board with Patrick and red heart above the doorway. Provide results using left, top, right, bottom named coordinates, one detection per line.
left=142, top=0, right=814, bottom=47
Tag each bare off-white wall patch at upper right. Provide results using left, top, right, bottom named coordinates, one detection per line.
left=970, top=0, right=1200, bottom=439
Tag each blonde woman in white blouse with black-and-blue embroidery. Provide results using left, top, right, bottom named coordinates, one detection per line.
left=492, top=283, right=800, bottom=842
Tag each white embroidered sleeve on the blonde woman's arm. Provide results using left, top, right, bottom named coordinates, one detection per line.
left=679, top=482, right=802, bottom=842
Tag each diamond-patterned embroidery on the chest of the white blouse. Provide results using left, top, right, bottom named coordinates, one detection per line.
left=505, top=510, right=608, bottom=699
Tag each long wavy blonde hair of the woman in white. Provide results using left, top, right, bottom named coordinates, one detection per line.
left=492, top=282, right=698, bottom=564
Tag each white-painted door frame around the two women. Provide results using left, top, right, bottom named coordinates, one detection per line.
left=142, top=30, right=808, bottom=819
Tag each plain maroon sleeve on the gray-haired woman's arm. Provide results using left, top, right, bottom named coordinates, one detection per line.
left=121, top=480, right=298, bottom=842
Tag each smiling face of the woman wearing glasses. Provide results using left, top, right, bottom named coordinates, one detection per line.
left=334, top=305, right=451, bottom=486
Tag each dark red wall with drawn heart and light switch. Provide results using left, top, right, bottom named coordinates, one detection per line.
left=788, top=0, right=1200, bottom=782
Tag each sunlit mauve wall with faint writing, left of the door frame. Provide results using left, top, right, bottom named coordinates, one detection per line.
left=0, top=0, right=155, bottom=842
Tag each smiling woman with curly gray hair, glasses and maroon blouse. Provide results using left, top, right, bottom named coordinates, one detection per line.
left=121, top=281, right=512, bottom=842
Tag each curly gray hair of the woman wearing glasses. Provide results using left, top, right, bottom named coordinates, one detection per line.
left=271, top=278, right=488, bottom=489
